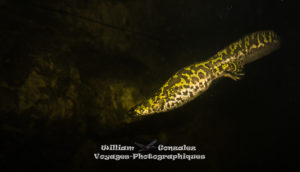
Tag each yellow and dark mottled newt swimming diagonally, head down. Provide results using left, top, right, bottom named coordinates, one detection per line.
left=129, top=31, right=280, bottom=116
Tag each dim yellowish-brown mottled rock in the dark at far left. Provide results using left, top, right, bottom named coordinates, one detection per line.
left=18, top=56, right=81, bottom=118
